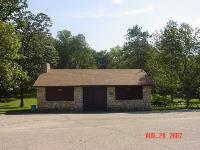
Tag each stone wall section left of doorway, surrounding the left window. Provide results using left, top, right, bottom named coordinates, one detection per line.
left=37, top=87, right=83, bottom=111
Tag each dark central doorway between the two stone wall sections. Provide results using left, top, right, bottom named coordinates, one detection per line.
left=83, top=86, right=107, bottom=111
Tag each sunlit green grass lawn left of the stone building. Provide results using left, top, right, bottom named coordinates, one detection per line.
left=0, top=98, right=37, bottom=114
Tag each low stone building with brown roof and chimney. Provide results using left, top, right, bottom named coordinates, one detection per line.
left=34, top=64, right=154, bottom=111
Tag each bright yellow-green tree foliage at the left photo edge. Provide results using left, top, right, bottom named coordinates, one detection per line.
left=0, top=22, right=27, bottom=97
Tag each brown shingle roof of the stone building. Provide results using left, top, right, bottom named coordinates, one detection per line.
left=34, top=69, right=154, bottom=87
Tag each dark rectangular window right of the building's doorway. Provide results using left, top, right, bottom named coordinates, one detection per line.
left=115, top=86, right=143, bottom=100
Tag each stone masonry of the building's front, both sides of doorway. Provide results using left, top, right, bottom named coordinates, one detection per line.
left=37, top=86, right=151, bottom=111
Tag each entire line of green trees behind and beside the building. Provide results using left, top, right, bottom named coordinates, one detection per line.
left=0, top=0, right=200, bottom=107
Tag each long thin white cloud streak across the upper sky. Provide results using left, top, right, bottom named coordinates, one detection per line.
left=68, top=5, right=154, bottom=18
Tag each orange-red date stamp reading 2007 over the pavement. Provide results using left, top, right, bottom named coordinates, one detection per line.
left=146, top=132, right=183, bottom=140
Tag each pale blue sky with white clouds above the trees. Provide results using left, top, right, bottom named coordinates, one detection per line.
left=28, top=0, right=200, bottom=51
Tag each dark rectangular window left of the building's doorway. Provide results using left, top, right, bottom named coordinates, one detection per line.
left=46, top=87, right=74, bottom=101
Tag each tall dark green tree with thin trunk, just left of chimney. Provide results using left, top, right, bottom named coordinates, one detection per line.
left=16, top=12, right=58, bottom=107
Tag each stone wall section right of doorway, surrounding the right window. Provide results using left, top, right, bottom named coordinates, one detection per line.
left=107, top=86, right=151, bottom=111
